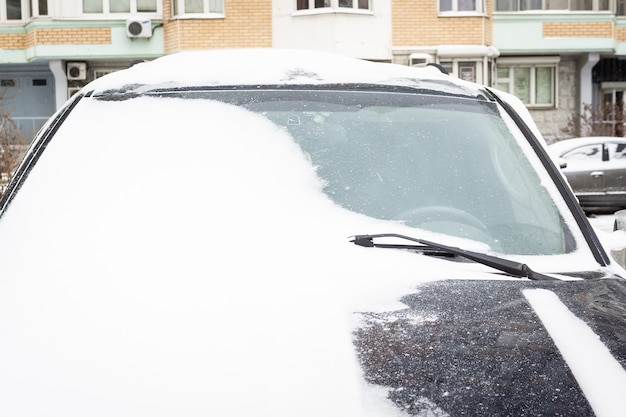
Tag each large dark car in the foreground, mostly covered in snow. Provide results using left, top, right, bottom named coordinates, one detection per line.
left=0, top=49, right=626, bottom=417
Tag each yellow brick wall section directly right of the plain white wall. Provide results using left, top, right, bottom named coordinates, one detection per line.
left=391, top=0, right=493, bottom=47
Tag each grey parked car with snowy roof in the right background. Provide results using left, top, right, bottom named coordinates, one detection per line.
left=550, top=136, right=626, bottom=213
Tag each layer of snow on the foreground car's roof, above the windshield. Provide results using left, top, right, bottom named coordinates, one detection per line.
left=87, top=48, right=482, bottom=96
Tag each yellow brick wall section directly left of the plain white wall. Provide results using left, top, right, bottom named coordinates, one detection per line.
left=163, top=0, right=272, bottom=54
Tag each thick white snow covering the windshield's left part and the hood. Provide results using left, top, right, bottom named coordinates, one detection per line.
left=0, top=97, right=502, bottom=417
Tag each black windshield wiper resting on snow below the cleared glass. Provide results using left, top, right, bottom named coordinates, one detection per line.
left=350, top=233, right=558, bottom=280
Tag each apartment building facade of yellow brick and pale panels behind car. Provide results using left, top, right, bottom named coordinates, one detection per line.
left=0, top=0, right=626, bottom=141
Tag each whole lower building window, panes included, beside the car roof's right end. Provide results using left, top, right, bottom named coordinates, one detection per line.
left=496, top=59, right=557, bottom=107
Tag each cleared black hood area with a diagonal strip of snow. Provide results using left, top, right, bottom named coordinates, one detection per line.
left=355, top=279, right=626, bottom=416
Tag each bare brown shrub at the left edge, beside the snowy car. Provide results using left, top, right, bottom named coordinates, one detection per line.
left=0, top=107, right=26, bottom=196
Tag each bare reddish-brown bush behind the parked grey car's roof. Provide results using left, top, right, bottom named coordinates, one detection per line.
left=562, top=104, right=624, bottom=137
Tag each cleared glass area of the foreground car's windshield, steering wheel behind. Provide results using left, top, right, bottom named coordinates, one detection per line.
left=149, top=90, right=575, bottom=255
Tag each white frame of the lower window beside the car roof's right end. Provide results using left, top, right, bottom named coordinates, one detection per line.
left=495, top=56, right=560, bottom=109
